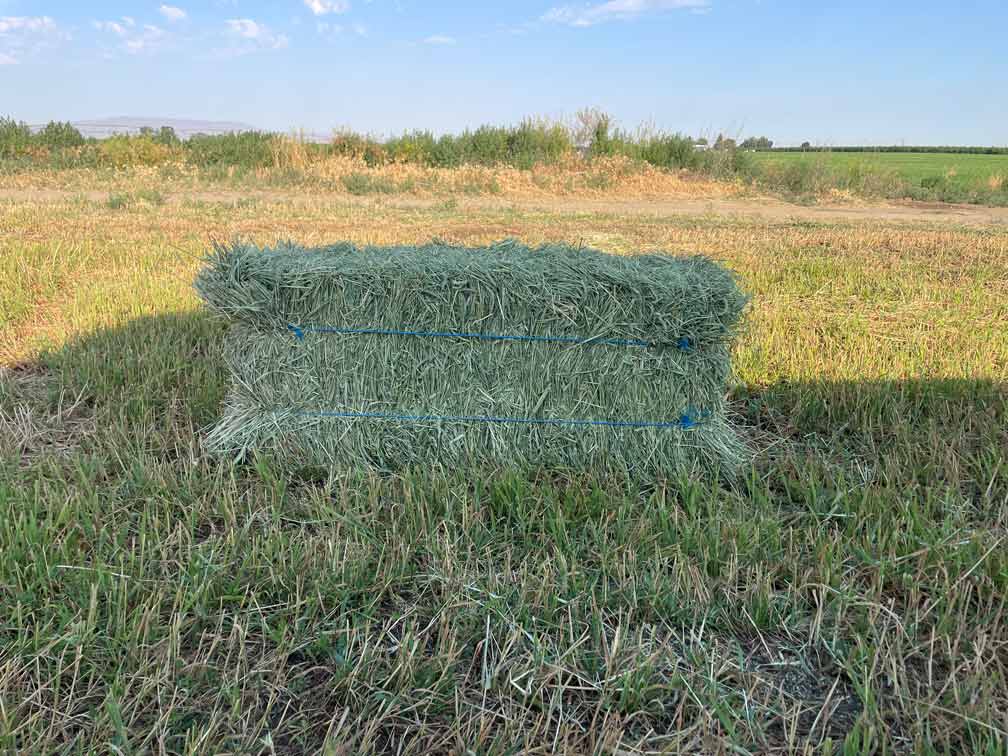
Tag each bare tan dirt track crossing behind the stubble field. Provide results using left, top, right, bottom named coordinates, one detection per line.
left=0, top=188, right=1008, bottom=227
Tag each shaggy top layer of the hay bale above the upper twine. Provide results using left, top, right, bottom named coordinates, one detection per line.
left=196, top=241, right=746, bottom=347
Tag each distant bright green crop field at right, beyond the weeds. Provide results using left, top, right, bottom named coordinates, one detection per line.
left=752, top=152, right=1008, bottom=200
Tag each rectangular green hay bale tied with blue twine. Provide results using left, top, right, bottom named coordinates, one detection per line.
left=196, top=242, right=746, bottom=476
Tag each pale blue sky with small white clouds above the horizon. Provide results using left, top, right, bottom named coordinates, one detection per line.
left=0, top=0, right=1008, bottom=145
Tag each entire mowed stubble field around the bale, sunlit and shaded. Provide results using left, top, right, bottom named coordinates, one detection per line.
left=0, top=180, right=1008, bottom=756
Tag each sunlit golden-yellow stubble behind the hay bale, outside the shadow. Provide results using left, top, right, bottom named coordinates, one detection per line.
left=0, top=196, right=1008, bottom=378
